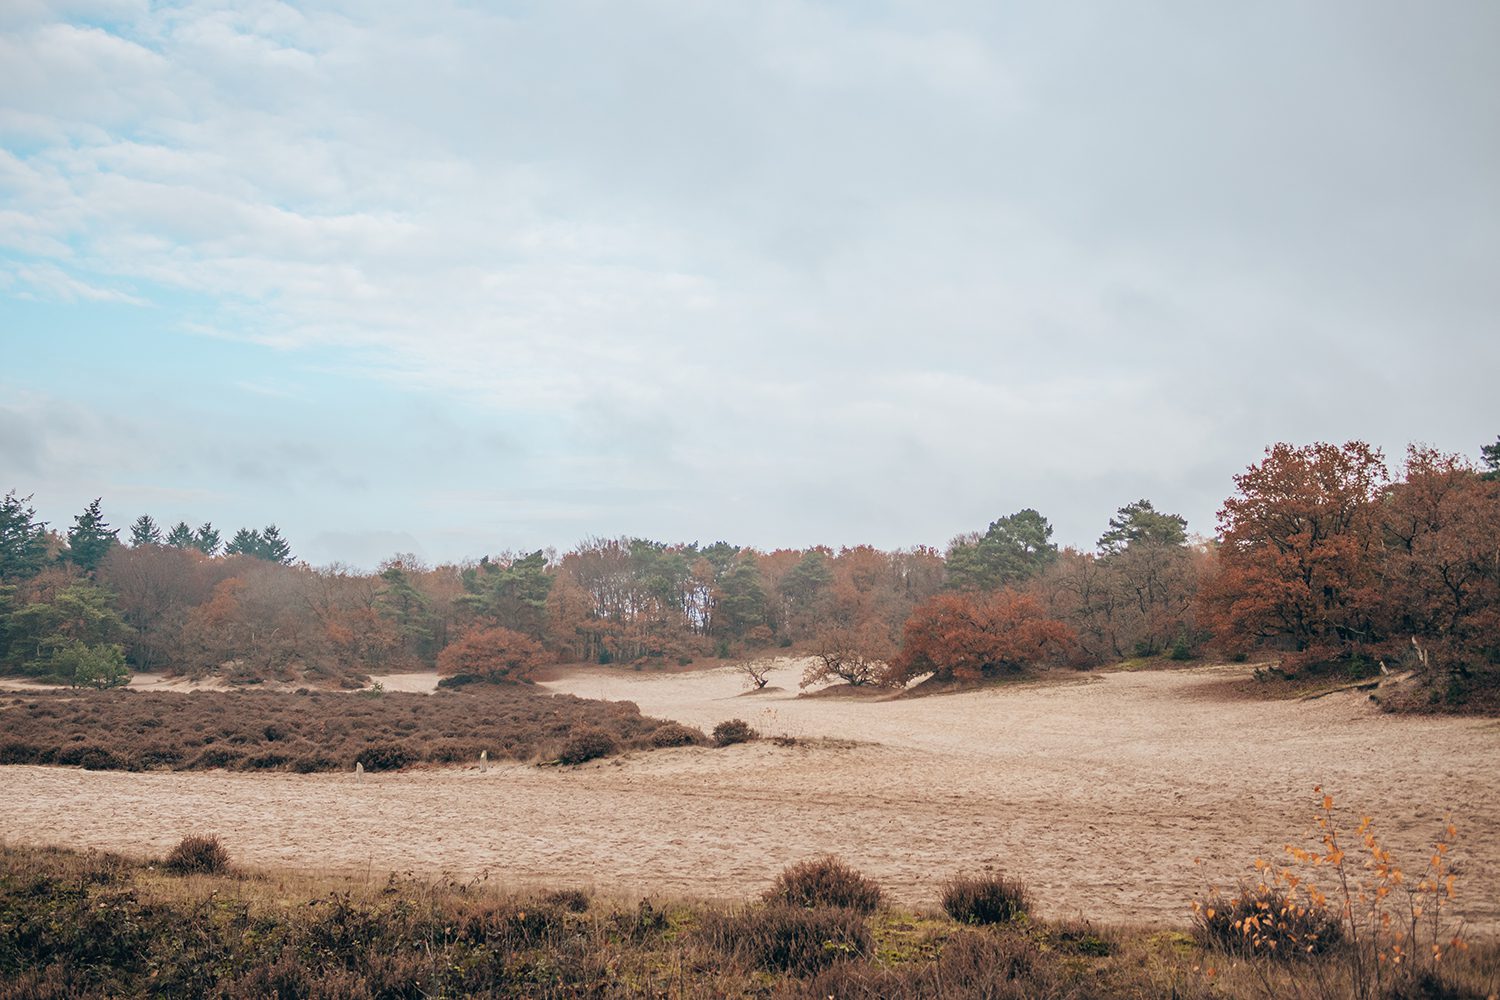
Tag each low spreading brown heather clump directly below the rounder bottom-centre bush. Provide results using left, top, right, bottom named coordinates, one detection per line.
left=702, top=904, right=870, bottom=976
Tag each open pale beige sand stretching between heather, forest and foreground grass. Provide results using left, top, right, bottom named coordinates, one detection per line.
left=0, top=667, right=1500, bottom=934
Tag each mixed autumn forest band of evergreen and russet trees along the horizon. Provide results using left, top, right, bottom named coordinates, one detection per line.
left=0, top=441, right=1500, bottom=709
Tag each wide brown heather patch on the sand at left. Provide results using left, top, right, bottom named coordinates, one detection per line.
left=0, top=685, right=675, bottom=774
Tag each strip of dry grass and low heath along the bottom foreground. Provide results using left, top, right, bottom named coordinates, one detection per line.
left=0, top=846, right=1500, bottom=1000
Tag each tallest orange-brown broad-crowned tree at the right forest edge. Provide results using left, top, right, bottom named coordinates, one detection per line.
left=1200, top=441, right=1386, bottom=666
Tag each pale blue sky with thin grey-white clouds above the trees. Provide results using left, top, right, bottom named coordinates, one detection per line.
left=0, top=0, right=1500, bottom=568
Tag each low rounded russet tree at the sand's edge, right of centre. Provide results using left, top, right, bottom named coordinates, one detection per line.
left=890, top=589, right=1074, bottom=684
